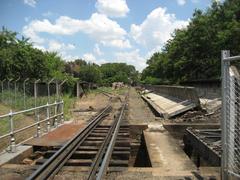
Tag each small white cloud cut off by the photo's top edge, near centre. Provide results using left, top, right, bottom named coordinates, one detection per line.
left=95, top=0, right=129, bottom=17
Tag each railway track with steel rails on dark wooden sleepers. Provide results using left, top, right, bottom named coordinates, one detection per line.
left=28, top=96, right=130, bottom=180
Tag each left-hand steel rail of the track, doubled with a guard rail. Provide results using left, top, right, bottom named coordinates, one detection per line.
left=27, top=104, right=112, bottom=180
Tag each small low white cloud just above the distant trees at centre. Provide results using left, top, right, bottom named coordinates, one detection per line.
left=115, top=49, right=146, bottom=71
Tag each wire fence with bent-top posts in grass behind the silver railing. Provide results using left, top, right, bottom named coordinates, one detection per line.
left=0, top=78, right=66, bottom=110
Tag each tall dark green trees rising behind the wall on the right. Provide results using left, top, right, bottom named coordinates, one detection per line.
left=141, top=0, right=240, bottom=84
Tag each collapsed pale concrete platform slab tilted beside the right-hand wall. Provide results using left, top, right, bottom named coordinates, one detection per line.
left=142, top=93, right=197, bottom=119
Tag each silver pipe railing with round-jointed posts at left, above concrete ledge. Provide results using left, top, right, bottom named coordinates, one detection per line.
left=0, top=101, right=64, bottom=153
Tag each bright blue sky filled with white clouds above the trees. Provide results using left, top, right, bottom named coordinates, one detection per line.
left=0, top=0, right=218, bottom=71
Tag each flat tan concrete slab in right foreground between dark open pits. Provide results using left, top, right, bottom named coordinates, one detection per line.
left=143, top=128, right=196, bottom=171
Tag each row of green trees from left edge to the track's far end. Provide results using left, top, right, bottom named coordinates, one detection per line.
left=0, top=27, right=138, bottom=85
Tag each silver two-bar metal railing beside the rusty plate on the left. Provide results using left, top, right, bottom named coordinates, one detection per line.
left=0, top=101, right=64, bottom=153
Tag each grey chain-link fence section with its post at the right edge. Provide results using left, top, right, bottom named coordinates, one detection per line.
left=221, top=51, right=240, bottom=180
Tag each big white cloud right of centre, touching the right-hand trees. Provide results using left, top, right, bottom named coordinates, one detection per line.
left=130, top=7, right=188, bottom=49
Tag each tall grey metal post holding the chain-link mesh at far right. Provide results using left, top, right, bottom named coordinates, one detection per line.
left=221, top=50, right=230, bottom=179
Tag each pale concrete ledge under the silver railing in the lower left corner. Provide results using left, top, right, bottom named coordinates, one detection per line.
left=0, top=145, right=32, bottom=166
